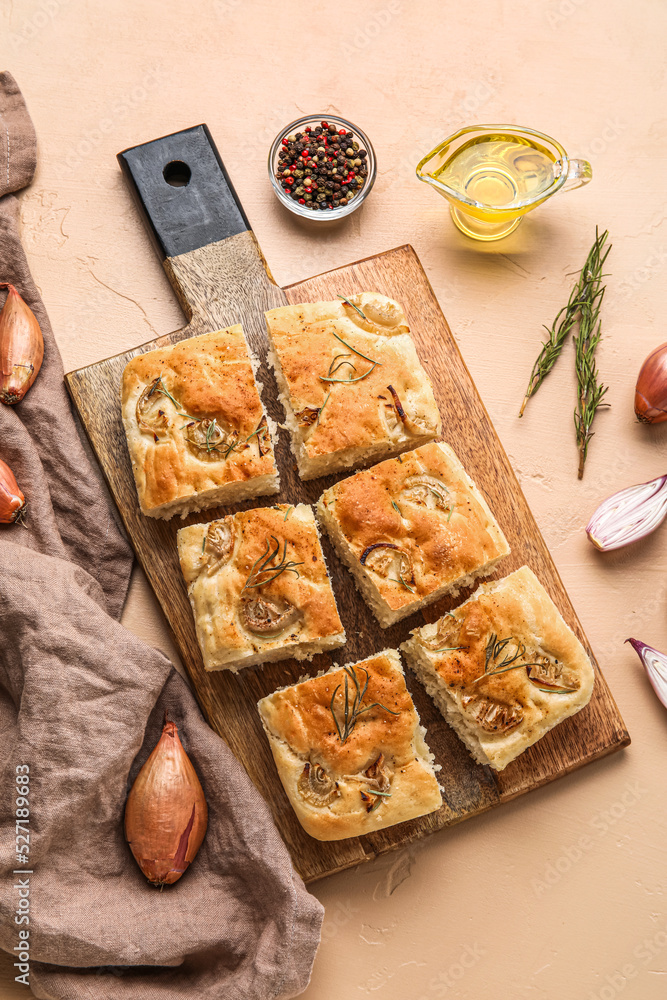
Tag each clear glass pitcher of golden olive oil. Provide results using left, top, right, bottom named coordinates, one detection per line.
left=417, top=125, right=593, bottom=240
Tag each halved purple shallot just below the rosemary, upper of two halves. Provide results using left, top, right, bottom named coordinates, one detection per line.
left=586, top=476, right=667, bottom=552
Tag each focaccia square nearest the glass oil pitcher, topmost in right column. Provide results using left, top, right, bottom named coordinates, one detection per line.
left=266, top=292, right=440, bottom=479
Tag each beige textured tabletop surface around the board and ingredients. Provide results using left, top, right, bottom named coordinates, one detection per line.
left=0, top=0, right=667, bottom=1000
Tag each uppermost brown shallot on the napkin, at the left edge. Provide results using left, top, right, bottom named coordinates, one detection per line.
left=0, top=281, right=44, bottom=406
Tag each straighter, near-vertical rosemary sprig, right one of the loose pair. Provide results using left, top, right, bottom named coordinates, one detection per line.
left=574, top=229, right=611, bottom=479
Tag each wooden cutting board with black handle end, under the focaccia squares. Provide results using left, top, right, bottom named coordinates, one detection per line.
left=66, top=126, right=630, bottom=882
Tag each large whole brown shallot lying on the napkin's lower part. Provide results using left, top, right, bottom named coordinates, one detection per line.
left=125, top=722, right=208, bottom=886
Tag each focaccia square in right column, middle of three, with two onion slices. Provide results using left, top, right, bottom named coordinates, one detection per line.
left=317, top=442, right=509, bottom=628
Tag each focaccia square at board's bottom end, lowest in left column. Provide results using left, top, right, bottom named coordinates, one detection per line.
left=258, top=649, right=442, bottom=840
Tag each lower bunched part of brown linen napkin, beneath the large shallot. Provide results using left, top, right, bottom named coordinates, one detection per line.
left=0, top=542, right=322, bottom=1000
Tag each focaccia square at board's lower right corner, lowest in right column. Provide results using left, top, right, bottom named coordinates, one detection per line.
left=401, top=566, right=594, bottom=771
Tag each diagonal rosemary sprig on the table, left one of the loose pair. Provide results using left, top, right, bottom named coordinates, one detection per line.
left=519, top=229, right=611, bottom=430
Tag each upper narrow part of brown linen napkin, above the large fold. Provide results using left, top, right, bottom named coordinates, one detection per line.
left=0, top=73, right=132, bottom=618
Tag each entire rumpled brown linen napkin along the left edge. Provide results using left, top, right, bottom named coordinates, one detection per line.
left=0, top=73, right=322, bottom=1000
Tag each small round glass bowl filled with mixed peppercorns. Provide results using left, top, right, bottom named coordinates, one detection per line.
left=269, top=115, right=376, bottom=222
